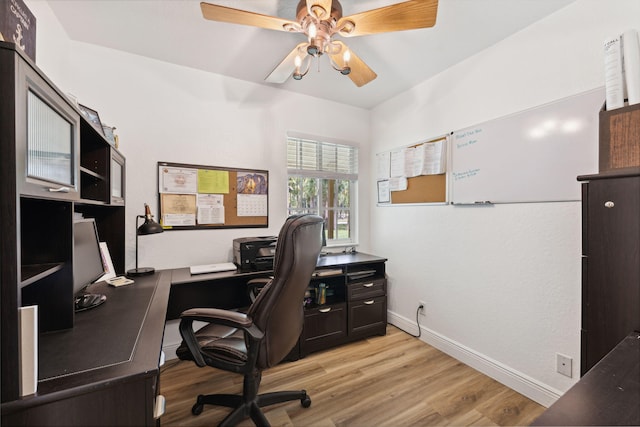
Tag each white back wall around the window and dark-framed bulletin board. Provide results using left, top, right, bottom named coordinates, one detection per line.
left=28, top=1, right=371, bottom=368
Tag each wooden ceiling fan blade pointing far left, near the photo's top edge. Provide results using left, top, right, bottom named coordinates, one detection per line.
left=200, top=2, right=300, bottom=31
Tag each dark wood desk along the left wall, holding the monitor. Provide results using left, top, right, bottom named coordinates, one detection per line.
left=2, top=271, right=171, bottom=426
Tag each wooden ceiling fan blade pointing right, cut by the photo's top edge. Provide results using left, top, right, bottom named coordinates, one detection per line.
left=336, top=0, right=438, bottom=37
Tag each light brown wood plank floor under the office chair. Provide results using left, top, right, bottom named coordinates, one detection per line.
left=160, top=326, right=545, bottom=427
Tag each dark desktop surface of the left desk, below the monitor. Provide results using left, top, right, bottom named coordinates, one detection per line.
left=2, top=272, right=170, bottom=417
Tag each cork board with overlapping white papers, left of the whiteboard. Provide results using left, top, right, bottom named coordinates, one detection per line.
left=376, top=135, right=449, bottom=206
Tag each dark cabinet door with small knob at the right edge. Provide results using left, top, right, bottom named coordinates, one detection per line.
left=582, top=177, right=640, bottom=373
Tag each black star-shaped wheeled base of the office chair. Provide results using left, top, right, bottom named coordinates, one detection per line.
left=191, top=390, right=311, bottom=427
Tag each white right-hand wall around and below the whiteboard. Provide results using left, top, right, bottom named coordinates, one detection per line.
left=371, top=0, right=640, bottom=404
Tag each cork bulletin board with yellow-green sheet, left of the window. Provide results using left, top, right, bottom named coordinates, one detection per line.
left=158, top=162, right=269, bottom=230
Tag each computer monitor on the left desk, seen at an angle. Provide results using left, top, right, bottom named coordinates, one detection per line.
left=73, top=218, right=107, bottom=311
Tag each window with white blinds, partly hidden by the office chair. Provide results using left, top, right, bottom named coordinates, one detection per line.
left=287, top=137, right=358, bottom=246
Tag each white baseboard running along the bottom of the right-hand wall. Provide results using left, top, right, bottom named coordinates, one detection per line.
left=387, top=311, right=562, bottom=407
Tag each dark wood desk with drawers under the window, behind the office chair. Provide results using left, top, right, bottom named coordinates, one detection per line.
left=167, top=252, right=387, bottom=360
